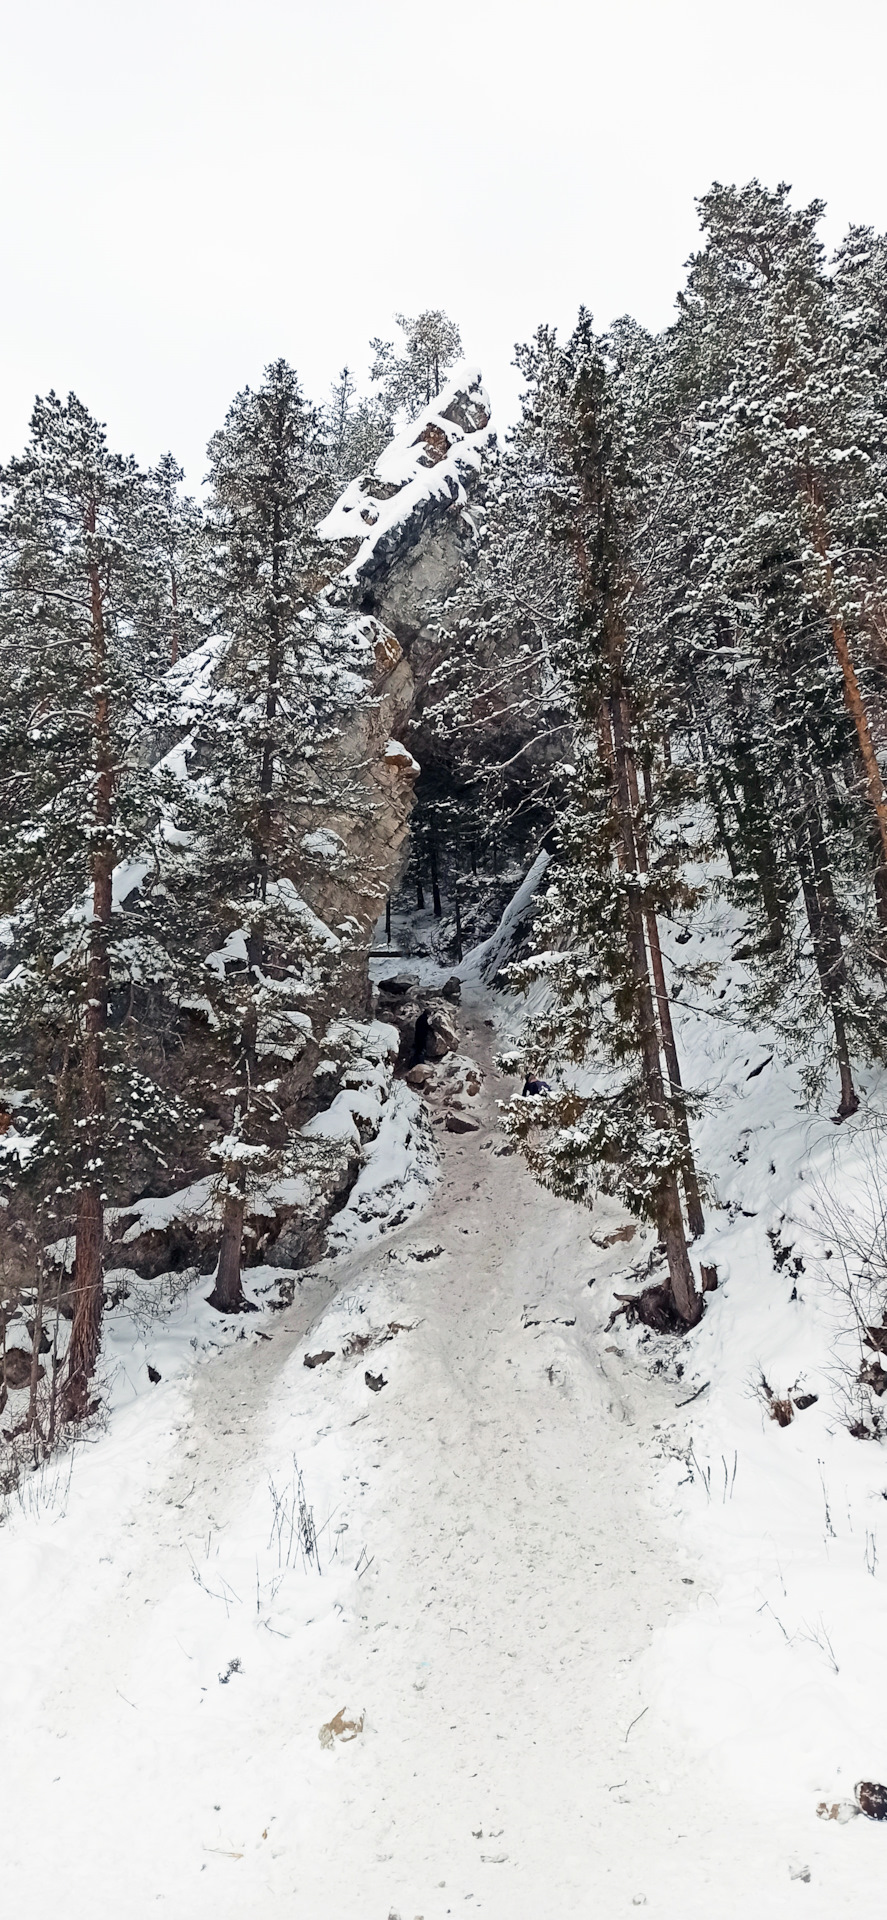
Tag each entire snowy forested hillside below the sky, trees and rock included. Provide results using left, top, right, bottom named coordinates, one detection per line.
left=0, top=179, right=887, bottom=1920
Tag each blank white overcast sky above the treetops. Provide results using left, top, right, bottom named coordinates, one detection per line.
left=0, top=0, right=887, bottom=486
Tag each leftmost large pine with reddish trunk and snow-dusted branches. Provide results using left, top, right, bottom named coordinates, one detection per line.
left=0, top=394, right=191, bottom=1417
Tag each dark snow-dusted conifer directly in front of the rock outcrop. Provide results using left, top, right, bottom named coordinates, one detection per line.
left=152, top=361, right=363, bottom=1313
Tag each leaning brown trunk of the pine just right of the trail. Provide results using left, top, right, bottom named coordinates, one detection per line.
left=601, top=697, right=703, bottom=1327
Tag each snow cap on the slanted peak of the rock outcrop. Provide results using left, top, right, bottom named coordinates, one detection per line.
left=317, top=367, right=493, bottom=586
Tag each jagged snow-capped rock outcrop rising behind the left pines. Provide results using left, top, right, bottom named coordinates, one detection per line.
left=6, top=380, right=491, bottom=1292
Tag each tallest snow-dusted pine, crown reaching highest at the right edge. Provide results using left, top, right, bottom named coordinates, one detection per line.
left=672, top=182, right=887, bottom=1117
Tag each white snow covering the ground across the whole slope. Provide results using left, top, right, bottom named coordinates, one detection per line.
left=0, top=906, right=887, bottom=1920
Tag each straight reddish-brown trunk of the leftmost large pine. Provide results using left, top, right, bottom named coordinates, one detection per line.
left=63, top=533, right=113, bottom=1419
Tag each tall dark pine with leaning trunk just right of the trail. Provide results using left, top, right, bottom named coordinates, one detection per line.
left=507, top=313, right=703, bottom=1325
